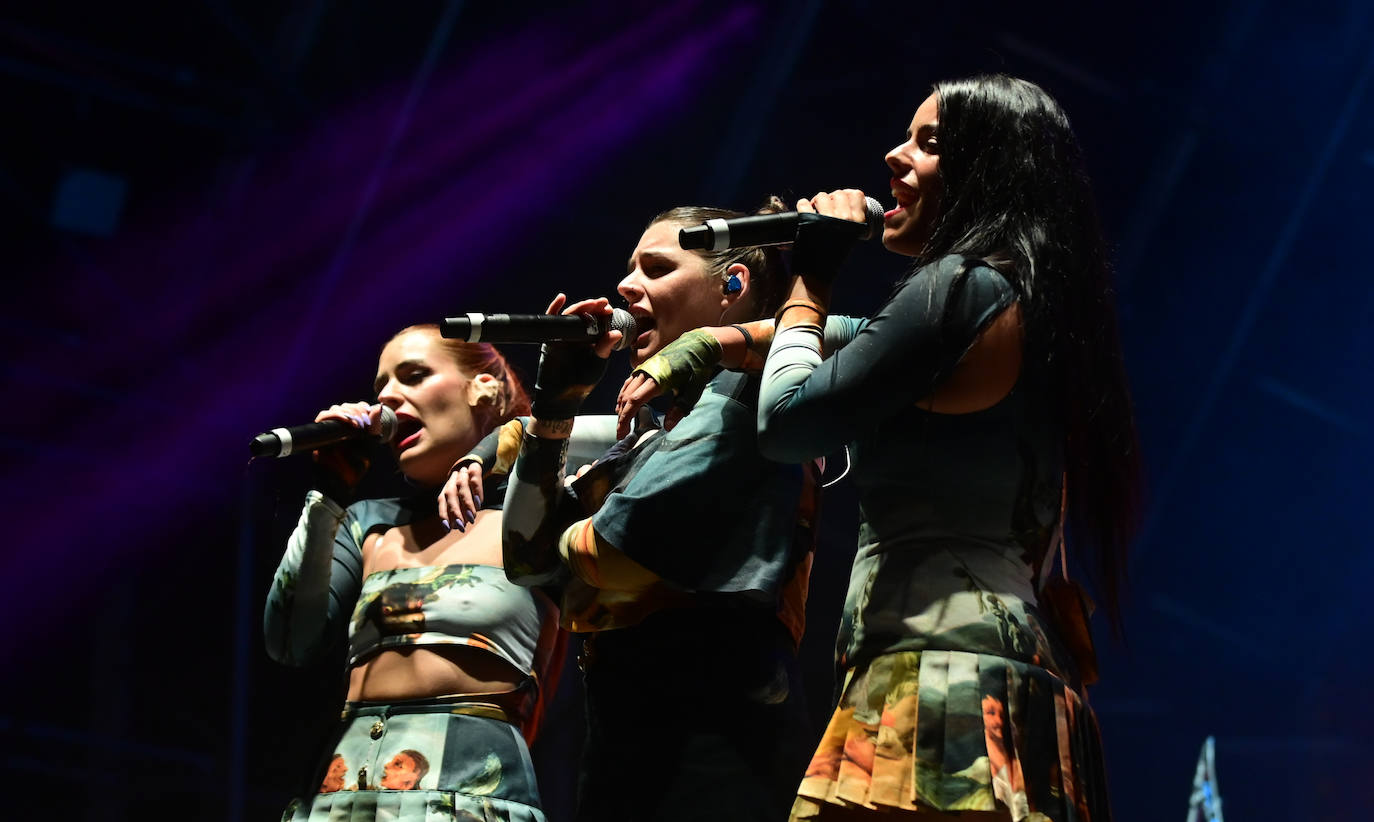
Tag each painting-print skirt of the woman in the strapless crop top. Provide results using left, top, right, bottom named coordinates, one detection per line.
left=282, top=700, right=544, bottom=822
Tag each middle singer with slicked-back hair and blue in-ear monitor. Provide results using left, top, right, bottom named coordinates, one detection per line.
left=491, top=209, right=815, bottom=822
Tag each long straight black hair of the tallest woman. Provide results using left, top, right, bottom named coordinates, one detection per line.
left=918, top=74, right=1142, bottom=630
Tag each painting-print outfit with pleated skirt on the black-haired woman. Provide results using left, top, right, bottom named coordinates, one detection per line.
left=760, top=257, right=1109, bottom=822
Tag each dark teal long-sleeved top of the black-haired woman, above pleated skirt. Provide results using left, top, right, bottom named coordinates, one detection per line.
left=758, top=257, right=1066, bottom=676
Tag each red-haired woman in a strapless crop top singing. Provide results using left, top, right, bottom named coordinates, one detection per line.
left=264, top=326, right=562, bottom=821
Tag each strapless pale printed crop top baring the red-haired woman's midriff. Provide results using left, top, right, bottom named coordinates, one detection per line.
left=348, top=565, right=552, bottom=675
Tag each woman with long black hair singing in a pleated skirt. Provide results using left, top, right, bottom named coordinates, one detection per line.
left=621, top=76, right=1139, bottom=822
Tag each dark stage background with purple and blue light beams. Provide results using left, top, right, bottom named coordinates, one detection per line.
left=0, top=0, right=1374, bottom=822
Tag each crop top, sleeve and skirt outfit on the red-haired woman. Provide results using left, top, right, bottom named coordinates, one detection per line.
left=264, top=491, right=552, bottom=822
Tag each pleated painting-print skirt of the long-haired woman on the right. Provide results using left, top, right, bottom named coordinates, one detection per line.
left=791, top=650, right=1110, bottom=822
